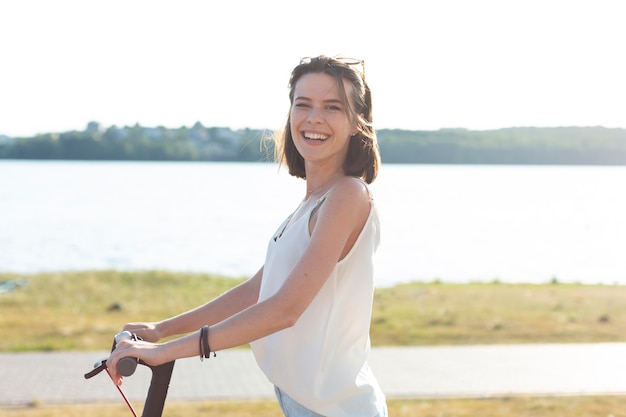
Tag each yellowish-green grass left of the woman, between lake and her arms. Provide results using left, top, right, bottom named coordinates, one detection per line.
left=0, top=271, right=239, bottom=352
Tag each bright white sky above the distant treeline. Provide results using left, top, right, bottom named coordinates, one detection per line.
left=0, top=0, right=626, bottom=136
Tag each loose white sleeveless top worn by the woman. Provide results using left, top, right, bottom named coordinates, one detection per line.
left=251, top=191, right=385, bottom=417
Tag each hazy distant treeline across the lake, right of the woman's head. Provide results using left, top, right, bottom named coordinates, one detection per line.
left=379, top=127, right=626, bottom=165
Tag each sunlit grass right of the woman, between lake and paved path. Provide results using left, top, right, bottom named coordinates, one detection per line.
left=372, top=283, right=626, bottom=345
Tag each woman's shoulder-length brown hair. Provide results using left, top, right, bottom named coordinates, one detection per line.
left=274, top=56, right=380, bottom=184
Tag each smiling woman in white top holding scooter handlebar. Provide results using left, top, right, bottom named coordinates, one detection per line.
left=108, top=56, right=387, bottom=417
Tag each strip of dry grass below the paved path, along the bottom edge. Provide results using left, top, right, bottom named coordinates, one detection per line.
left=0, top=396, right=626, bottom=417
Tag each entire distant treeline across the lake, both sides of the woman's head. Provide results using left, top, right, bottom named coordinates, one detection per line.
left=0, top=122, right=626, bottom=165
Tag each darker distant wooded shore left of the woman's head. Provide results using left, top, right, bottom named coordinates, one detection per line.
left=0, top=122, right=273, bottom=161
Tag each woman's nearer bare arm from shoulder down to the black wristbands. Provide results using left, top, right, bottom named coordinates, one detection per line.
left=209, top=177, right=371, bottom=350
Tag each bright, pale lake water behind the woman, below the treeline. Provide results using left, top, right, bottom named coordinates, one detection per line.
left=0, top=161, right=626, bottom=286
